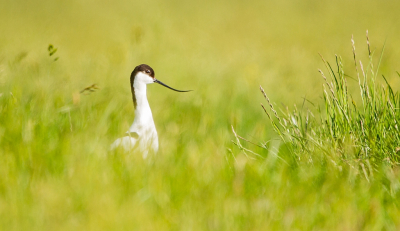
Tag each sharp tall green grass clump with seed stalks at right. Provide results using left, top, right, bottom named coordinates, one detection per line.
left=261, top=33, right=400, bottom=176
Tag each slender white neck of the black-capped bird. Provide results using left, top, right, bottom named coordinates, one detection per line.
left=129, top=82, right=154, bottom=132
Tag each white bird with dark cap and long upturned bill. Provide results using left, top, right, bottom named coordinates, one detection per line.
left=110, top=64, right=191, bottom=159
